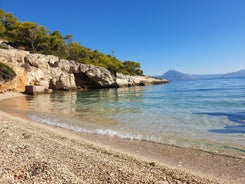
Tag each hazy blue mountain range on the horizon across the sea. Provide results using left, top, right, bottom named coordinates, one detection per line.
left=158, top=70, right=245, bottom=80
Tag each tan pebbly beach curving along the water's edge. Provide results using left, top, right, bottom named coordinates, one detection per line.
left=0, top=93, right=245, bottom=183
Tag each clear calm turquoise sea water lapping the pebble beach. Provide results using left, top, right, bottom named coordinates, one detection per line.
left=0, top=78, right=245, bottom=157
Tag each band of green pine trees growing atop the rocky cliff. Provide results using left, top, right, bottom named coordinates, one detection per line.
left=0, top=10, right=143, bottom=75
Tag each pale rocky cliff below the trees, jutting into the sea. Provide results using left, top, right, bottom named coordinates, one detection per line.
left=0, top=45, right=167, bottom=91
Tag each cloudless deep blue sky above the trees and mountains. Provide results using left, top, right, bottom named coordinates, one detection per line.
left=0, top=0, right=245, bottom=75
